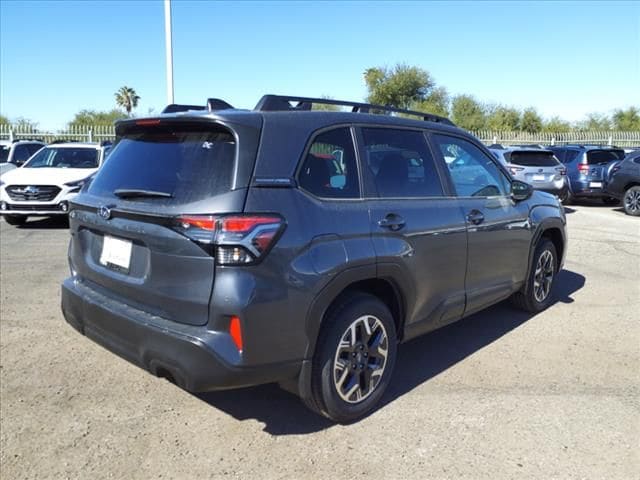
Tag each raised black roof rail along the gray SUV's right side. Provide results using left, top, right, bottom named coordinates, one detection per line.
left=254, top=95, right=455, bottom=126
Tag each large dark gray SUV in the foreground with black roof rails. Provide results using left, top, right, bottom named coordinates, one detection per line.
left=62, top=95, right=567, bottom=422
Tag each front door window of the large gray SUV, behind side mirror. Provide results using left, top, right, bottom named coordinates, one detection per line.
left=433, top=135, right=510, bottom=197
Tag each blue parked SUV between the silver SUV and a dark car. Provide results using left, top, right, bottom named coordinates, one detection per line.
left=549, top=145, right=625, bottom=204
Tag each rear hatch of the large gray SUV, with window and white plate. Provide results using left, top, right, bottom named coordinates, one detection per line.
left=69, top=118, right=260, bottom=325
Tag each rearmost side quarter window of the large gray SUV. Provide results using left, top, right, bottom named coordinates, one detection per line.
left=298, top=128, right=360, bottom=198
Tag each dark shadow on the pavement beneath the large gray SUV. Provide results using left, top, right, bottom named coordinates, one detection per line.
left=196, top=270, right=585, bottom=435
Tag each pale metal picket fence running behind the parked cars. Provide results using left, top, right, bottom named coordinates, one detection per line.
left=0, top=124, right=640, bottom=147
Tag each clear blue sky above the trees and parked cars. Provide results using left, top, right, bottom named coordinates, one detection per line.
left=0, top=0, right=640, bottom=128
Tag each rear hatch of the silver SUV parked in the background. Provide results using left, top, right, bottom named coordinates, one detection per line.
left=505, top=150, right=566, bottom=186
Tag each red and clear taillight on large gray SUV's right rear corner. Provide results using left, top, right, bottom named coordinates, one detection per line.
left=173, top=214, right=285, bottom=265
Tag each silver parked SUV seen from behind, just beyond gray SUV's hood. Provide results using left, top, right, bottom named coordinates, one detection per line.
left=490, top=147, right=568, bottom=201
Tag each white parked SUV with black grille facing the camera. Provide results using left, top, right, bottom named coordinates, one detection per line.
left=0, top=143, right=104, bottom=225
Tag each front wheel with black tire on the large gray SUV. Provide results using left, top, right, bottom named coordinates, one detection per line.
left=511, top=237, right=558, bottom=313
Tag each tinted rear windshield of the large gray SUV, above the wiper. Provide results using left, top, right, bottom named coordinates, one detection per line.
left=89, top=127, right=236, bottom=204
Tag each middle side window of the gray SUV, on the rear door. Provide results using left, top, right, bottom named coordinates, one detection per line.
left=362, top=128, right=443, bottom=198
